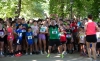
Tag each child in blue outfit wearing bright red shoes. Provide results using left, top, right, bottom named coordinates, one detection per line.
left=15, top=24, right=23, bottom=57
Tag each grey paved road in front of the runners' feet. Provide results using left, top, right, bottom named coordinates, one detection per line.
left=0, top=53, right=100, bottom=61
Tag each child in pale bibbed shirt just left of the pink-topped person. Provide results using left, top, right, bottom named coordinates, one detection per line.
left=78, top=28, right=86, bottom=56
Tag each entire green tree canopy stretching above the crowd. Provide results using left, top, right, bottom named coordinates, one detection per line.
left=0, top=0, right=100, bottom=19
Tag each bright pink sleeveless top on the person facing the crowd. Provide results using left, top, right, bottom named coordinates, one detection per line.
left=86, top=21, right=96, bottom=35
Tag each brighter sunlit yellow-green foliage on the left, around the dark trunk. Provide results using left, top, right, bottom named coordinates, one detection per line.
left=0, top=0, right=46, bottom=19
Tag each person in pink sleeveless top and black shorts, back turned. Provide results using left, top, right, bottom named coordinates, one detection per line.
left=85, top=15, right=98, bottom=61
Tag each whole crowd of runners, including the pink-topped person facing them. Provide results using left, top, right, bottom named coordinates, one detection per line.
left=0, top=14, right=100, bottom=61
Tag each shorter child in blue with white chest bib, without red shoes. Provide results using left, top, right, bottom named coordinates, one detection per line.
left=26, top=27, right=33, bottom=55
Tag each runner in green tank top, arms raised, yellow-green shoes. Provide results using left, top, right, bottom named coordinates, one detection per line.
left=47, top=14, right=64, bottom=58
